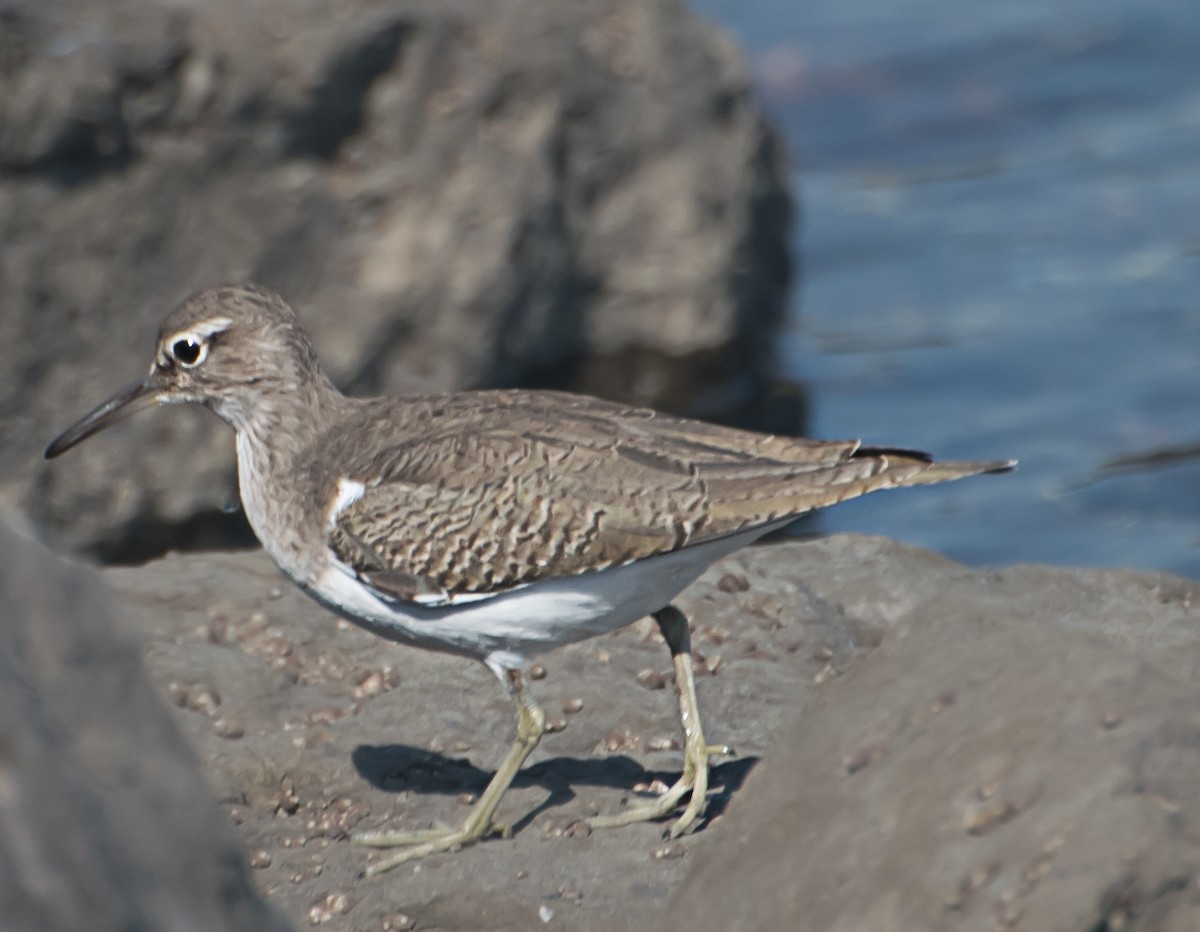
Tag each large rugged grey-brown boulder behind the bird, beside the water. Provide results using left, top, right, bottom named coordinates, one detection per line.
left=11, top=0, right=796, bottom=559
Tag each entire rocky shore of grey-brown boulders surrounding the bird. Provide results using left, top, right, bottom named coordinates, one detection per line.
left=0, top=0, right=1200, bottom=932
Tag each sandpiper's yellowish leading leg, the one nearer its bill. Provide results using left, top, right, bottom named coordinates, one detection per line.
left=354, top=669, right=546, bottom=877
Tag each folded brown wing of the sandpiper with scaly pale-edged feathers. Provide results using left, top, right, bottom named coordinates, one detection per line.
left=330, top=392, right=1002, bottom=605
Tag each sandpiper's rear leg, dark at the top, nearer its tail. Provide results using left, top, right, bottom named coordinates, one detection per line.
left=588, top=606, right=733, bottom=838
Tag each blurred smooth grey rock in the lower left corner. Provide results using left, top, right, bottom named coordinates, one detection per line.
left=0, top=527, right=287, bottom=932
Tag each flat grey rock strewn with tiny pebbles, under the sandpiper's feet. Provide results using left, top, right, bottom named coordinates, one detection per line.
left=104, top=534, right=844, bottom=930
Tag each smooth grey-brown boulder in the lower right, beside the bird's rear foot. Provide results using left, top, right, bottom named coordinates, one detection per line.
left=665, top=539, right=1200, bottom=932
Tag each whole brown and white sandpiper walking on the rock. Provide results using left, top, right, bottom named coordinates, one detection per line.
left=46, top=284, right=1013, bottom=873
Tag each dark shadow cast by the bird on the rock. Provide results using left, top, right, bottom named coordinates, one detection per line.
left=350, top=744, right=760, bottom=831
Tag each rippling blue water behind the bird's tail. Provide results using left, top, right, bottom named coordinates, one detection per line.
left=692, top=0, right=1200, bottom=577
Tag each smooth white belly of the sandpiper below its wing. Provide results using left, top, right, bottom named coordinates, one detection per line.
left=306, top=522, right=786, bottom=668
